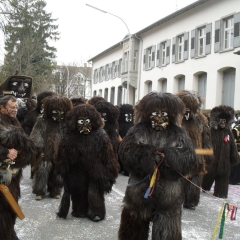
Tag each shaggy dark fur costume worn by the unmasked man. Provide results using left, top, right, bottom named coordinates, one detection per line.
left=0, top=126, right=35, bottom=240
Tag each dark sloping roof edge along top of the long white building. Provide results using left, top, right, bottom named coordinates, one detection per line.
left=88, top=0, right=210, bottom=62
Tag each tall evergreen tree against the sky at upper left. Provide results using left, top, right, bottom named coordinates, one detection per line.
left=4, top=0, right=59, bottom=93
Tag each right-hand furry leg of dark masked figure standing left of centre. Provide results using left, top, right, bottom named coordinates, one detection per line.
left=88, top=183, right=106, bottom=221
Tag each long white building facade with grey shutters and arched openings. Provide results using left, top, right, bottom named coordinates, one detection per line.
left=89, top=0, right=240, bottom=110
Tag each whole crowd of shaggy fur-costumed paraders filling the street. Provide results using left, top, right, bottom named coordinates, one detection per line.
left=0, top=76, right=240, bottom=240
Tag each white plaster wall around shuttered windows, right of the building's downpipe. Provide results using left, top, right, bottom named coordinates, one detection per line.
left=140, top=0, right=240, bottom=109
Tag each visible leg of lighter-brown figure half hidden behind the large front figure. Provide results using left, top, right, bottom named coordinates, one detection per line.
left=183, top=174, right=201, bottom=210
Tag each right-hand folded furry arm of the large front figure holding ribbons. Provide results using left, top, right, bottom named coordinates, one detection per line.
left=160, top=133, right=196, bottom=177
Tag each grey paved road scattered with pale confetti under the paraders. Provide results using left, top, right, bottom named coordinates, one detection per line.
left=15, top=167, right=240, bottom=240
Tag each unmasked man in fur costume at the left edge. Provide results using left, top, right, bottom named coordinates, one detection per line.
left=0, top=95, right=35, bottom=240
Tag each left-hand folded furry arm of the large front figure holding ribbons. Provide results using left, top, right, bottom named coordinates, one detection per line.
left=118, top=127, right=156, bottom=178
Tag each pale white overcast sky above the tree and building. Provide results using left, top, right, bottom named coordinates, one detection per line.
left=0, top=0, right=196, bottom=65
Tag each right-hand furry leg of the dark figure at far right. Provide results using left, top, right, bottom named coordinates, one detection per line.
left=213, top=174, right=229, bottom=198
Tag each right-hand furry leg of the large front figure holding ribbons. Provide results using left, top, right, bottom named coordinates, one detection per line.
left=152, top=213, right=182, bottom=240
